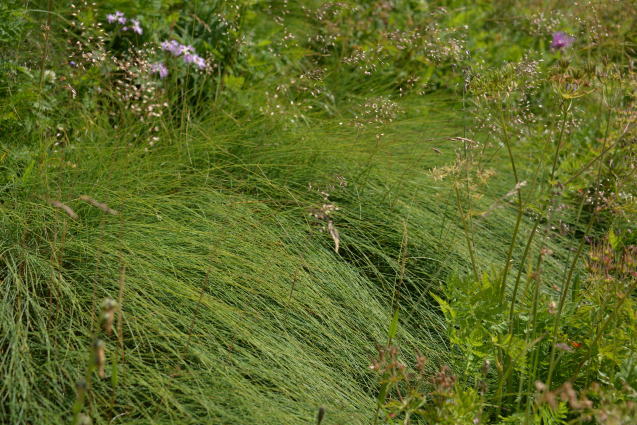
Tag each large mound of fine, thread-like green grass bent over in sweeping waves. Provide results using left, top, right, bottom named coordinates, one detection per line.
left=0, top=91, right=576, bottom=424
